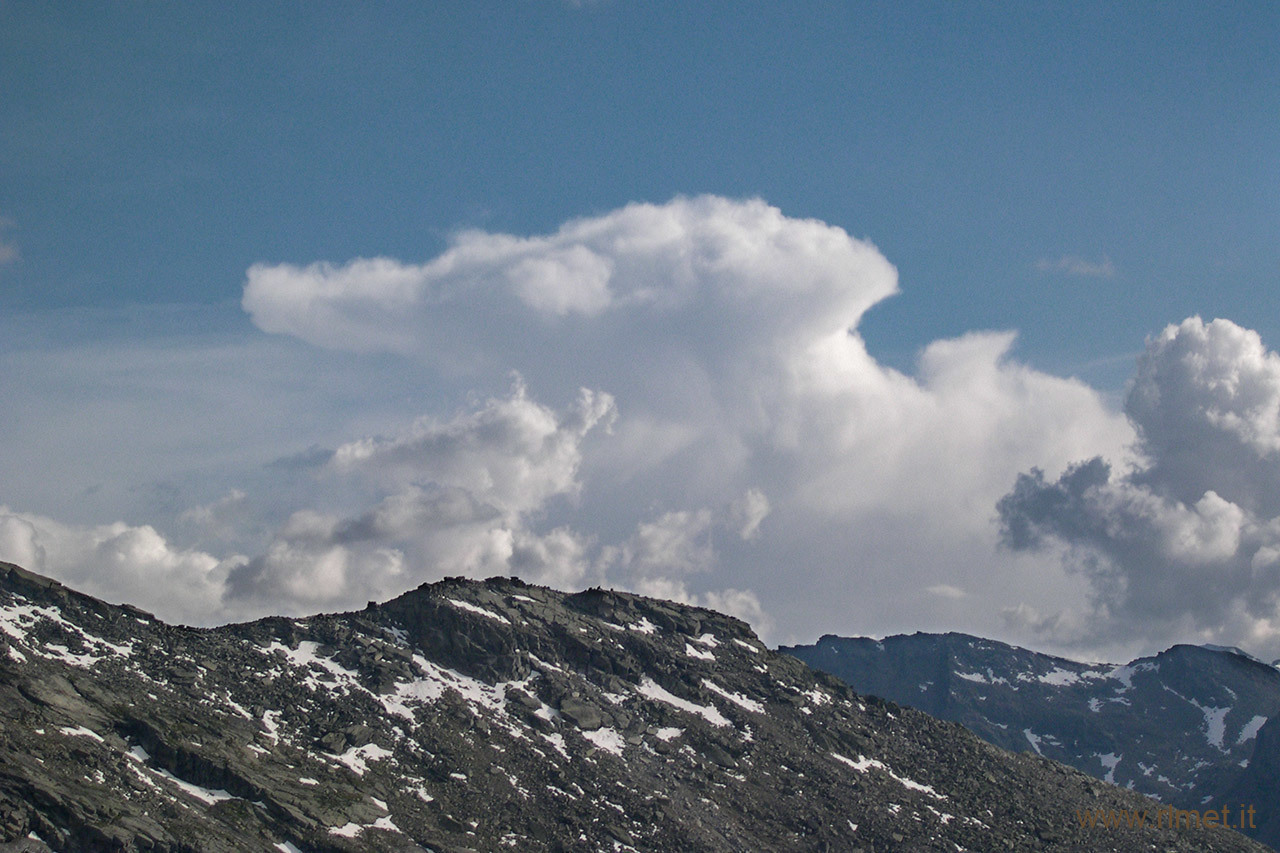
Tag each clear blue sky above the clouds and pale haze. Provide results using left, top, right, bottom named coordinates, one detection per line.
left=0, top=1, right=1280, bottom=378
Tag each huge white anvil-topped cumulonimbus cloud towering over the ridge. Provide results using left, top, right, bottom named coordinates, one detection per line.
left=230, top=197, right=1132, bottom=645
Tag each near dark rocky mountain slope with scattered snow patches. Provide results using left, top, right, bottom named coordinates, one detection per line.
left=0, top=564, right=1263, bottom=853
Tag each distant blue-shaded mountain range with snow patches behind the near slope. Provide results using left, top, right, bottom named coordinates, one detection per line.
left=781, top=634, right=1280, bottom=848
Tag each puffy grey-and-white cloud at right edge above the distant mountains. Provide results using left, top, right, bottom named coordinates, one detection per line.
left=998, top=318, right=1280, bottom=656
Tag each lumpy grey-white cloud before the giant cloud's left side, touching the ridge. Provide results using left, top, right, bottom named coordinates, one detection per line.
left=225, top=380, right=614, bottom=612
